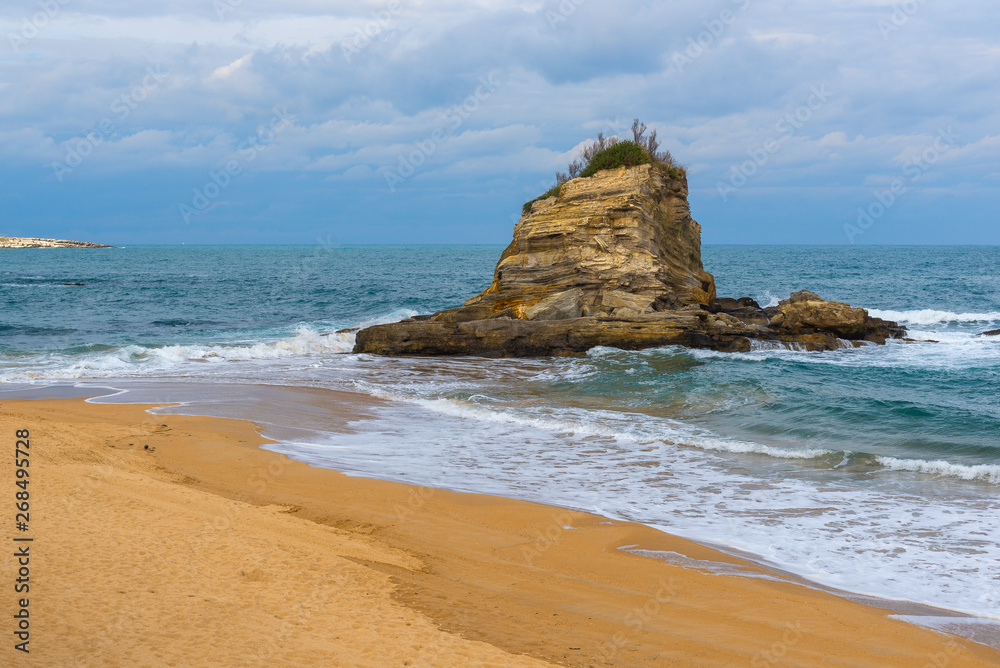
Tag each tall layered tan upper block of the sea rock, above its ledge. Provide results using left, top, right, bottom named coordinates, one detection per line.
left=466, top=165, right=715, bottom=320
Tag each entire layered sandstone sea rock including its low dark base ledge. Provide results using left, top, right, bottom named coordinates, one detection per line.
left=355, top=165, right=905, bottom=357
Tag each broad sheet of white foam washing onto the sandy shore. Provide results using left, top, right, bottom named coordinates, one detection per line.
left=252, top=391, right=1000, bottom=618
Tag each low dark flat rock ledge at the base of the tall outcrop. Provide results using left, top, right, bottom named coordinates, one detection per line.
left=355, top=290, right=905, bottom=357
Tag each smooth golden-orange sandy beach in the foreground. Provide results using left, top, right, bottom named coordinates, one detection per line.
left=0, top=393, right=1000, bottom=668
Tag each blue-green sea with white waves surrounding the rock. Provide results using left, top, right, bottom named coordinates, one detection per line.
left=0, top=244, right=1000, bottom=647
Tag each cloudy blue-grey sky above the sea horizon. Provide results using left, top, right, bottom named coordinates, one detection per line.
left=0, top=0, right=1000, bottom=245
